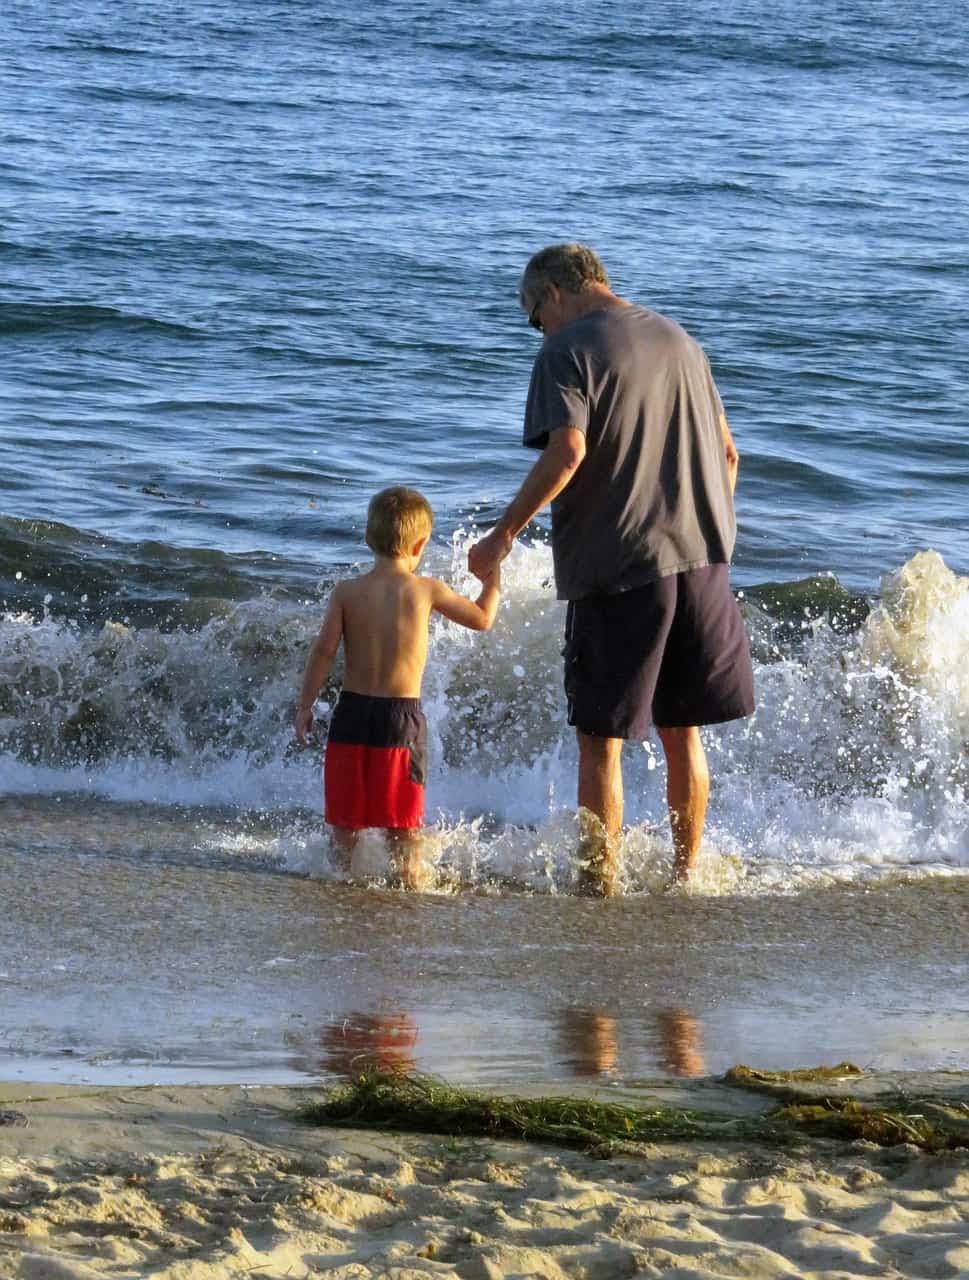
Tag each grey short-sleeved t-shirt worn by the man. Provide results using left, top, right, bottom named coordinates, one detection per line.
left=525, top=306, right=736, bottom=600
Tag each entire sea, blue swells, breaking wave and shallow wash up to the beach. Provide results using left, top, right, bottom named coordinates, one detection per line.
left=0, top=0, right=969, bottom=1079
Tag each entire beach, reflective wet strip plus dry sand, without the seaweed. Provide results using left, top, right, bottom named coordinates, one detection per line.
left=0, top=793, right=969, bottom=1280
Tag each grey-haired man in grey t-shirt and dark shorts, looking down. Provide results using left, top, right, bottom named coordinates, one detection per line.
left=468, top=244, right=754, bottom=895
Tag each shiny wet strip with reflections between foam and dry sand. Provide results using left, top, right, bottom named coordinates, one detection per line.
left=0, top=810, right=969, bottom=1087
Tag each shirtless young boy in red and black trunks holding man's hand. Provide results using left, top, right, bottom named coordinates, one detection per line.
left=296, top=488, right=501, bottom=888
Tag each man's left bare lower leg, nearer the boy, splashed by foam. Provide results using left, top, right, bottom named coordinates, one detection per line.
left=576, top=731, right=622, bottom=897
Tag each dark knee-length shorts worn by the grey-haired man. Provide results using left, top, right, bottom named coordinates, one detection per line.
left=562, top=564, right=754, bottom=739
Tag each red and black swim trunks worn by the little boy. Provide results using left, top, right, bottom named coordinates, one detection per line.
left=323, top=690, right=428, bottom=831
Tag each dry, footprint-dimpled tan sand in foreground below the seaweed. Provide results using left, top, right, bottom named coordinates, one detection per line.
left=0, top=1085, right=969, bottom=1280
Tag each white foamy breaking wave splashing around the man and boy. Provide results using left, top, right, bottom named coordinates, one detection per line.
left=0, top=545, right=969, bottom=892
